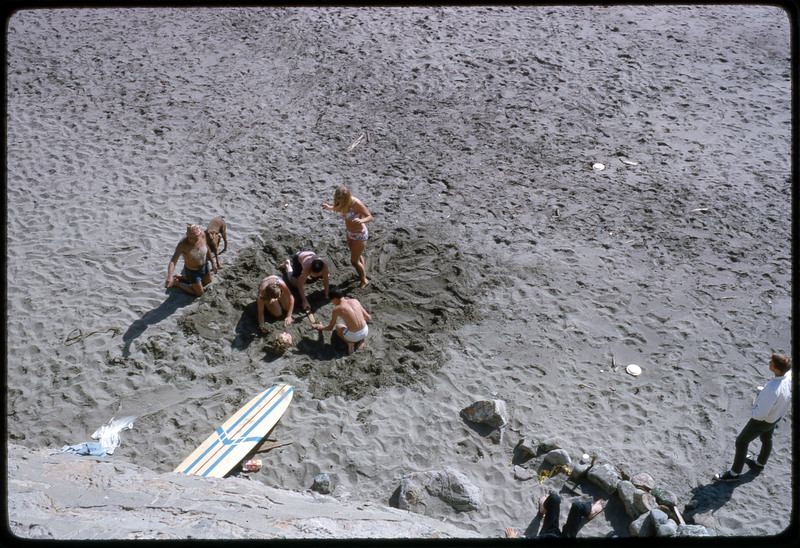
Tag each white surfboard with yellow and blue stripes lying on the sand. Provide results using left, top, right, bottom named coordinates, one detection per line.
left=175, top=384, right=294, bottom=478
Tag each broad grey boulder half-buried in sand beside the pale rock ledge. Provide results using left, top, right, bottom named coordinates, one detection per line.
left=397, top=467, right=482, bottom=512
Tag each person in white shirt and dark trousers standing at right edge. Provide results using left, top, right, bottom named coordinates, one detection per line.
left=714, top=354, right=792, bottom=481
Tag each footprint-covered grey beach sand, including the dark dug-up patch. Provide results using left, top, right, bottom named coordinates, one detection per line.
left=6, top=5, right=793, bottom=537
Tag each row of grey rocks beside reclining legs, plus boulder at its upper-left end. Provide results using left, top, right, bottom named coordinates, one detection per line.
left=461, top=400, right=716, bottom=537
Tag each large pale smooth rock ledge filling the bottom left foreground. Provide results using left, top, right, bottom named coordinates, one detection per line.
left=7, top=444, right=479, bottom=539
